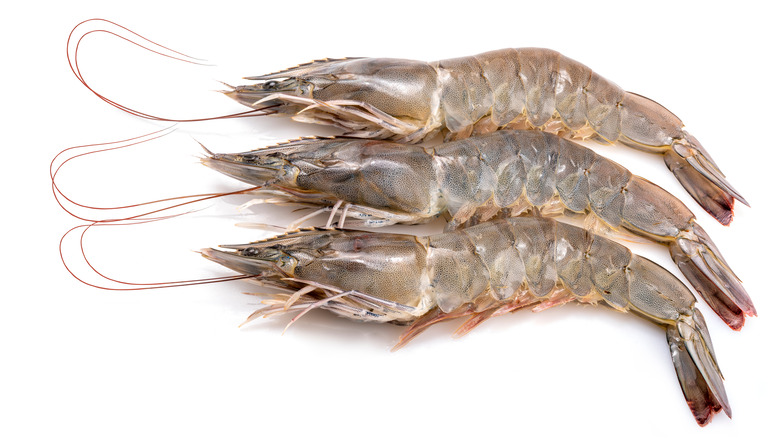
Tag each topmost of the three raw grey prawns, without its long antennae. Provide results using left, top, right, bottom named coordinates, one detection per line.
left=225, top=48, right=748, bottom=225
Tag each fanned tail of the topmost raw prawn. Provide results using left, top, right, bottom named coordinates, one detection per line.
left=664, top=133, right=750, bottom=225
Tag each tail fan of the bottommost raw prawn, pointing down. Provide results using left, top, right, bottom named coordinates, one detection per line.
left=666, top=309, right=731, bottom=426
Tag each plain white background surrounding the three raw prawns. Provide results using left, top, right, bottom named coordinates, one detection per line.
left=0, top=0, right=780, bottom=436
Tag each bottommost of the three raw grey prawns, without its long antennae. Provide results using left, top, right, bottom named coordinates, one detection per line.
left=201, top=217, right=731, bottom=426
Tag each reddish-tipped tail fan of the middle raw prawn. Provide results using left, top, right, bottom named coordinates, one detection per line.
left=670, top=224, right=756, bottom=330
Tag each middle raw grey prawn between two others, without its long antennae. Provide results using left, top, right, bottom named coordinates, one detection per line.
left=202, top=131, right=756, bottom=330
